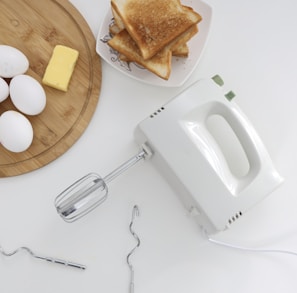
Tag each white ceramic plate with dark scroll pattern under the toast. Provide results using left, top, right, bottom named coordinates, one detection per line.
left=96, top=0, right=212, bottom=87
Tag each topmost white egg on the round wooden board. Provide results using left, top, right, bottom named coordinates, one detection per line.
left=0, top=45, right=29, bottom=78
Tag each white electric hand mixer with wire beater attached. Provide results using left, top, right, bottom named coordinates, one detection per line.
left=55, top=76, right=282, bottom=233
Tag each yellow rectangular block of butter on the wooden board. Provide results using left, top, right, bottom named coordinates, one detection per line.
left=42, top=45, right=79, bottom=92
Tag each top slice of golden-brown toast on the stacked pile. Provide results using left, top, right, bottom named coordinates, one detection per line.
left=111, top=0, right=202, bottom=60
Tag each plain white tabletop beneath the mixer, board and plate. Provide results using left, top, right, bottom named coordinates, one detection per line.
left=0, top=0, right=297, bottom=293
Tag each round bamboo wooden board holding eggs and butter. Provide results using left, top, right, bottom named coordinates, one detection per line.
left=0, top=0, right=102, bottom=177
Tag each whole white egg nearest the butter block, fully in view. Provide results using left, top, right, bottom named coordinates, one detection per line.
left=9, top=74, right=46, bottom=115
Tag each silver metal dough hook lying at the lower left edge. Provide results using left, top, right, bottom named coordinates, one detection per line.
left=0, top=246, right=86, bottom=270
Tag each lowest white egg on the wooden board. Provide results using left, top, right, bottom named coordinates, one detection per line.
left=0, top=110, right=33, bottom=153
